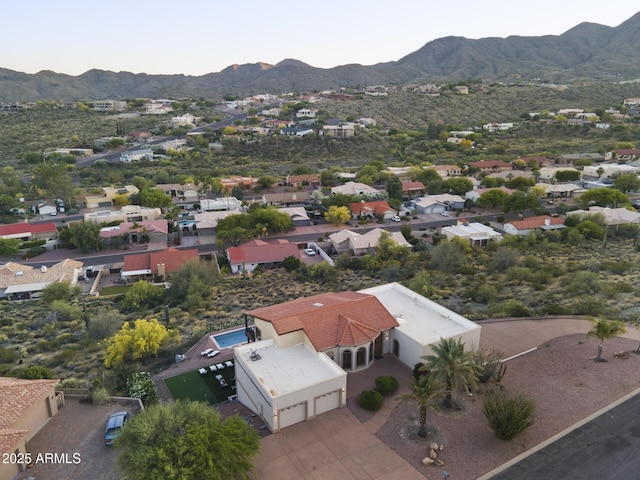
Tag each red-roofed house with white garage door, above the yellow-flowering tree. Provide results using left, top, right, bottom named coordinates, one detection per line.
left=120, top=248, right=199, bottom=283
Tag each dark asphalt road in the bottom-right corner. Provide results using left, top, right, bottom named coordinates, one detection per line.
left=491, top=395, right=640, bottom=480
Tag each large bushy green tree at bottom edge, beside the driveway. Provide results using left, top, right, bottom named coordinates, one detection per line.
left=115, top=401, right=260, bottom=480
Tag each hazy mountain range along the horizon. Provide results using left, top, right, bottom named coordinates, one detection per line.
left=0, top=12, right=640, bottom=103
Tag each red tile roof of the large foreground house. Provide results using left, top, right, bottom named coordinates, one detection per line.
left=246, top=292, right=398, bottom=351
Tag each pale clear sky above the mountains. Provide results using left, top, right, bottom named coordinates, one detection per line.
left=0, top=0, right=640, bottom=75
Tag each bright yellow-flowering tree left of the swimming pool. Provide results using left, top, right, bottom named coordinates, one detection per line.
left=104, top=319, right=178, bottom=368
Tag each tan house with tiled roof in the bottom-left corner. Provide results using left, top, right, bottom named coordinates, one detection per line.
left=0, top=377, right=63, bottom=480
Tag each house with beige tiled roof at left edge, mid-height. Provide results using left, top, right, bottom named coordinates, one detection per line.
left=0, top=258, right=83, bottom=301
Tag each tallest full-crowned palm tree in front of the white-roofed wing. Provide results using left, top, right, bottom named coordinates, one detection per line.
left=422, top=338, right=481, bottom=408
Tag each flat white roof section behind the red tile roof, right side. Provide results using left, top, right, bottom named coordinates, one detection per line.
left=359, top=283, right=480, bottom=345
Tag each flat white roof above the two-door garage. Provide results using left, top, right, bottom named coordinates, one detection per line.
left=235, top=340, right=347, bottom=398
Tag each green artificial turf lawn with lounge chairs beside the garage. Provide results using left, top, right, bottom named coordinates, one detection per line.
left=164, top=367, right=236, bottom=405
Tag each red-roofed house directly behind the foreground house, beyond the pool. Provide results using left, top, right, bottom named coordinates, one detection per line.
left=227, top=239, right=300, bottom=273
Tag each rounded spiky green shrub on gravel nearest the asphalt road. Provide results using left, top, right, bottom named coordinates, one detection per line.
left=482, top=392, right=536, bottom=440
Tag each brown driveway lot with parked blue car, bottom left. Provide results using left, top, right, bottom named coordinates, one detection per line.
left=22, top=397, right=136, bottom=480
